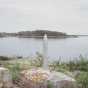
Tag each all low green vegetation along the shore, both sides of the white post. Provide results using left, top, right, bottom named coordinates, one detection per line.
left=0, top=54, right=88, bottom=88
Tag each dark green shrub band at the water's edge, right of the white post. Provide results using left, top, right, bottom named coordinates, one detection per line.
left=53, top=56, right=88, bottom=72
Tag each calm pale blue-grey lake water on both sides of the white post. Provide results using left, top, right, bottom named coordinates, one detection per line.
left=0, top=37, right=88, bottom=61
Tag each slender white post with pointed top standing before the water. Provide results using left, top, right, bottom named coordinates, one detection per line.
left=43, top=34, right=48, bottom=69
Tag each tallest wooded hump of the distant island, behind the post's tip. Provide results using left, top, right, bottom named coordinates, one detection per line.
left=18, top=30, right=67, bottom=38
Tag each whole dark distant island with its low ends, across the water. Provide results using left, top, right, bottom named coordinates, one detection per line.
left=0, top=30, right=77, bottom=38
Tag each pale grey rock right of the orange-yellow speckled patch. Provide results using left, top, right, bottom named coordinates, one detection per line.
left=49, top=72, right=77, bottom=88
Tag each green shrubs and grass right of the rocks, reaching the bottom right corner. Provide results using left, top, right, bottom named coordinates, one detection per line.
left=52, top=55, right=88, bottom=88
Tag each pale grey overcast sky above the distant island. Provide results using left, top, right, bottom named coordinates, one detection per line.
left=0, top=0, right=88, bottom=34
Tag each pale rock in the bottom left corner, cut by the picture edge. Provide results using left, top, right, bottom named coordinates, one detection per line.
left=0, top=67, right=13, bottom=88
